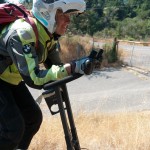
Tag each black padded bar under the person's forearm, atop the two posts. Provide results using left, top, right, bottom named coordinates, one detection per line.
left=43, top=73, right=82, bottom=90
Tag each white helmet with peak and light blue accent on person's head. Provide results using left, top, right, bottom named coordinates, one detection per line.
left=32, top=0, right=86, bottom=33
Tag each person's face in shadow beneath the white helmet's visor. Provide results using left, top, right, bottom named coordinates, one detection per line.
left=55, top=10, right=70, bottom=35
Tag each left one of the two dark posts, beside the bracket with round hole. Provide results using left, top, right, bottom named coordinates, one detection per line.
left=55, top=87, right=74, bottom=150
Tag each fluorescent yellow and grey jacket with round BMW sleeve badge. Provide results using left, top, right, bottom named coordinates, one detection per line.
left=0, top=19, right=68, bottom=88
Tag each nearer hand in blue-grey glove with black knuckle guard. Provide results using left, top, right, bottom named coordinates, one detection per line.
left=70, top=57, right=94, bottom=75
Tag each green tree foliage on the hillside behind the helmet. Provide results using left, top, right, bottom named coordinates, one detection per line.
left=70, top=0, right=150, bottom=40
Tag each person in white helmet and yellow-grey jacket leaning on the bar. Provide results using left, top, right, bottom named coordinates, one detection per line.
left=0, top=0, right=86, bottom=150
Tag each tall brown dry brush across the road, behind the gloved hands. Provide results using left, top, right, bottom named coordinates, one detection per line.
left=60, top=35, right=123, bottom=69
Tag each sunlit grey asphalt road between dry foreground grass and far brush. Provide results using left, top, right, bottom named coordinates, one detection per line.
left=30, top=68, right=150, bottom=113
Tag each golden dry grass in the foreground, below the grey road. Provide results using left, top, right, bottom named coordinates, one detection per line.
left=30, top=112, right=150, bottom=150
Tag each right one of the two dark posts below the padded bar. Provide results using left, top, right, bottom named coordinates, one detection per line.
left=61, top=84, right=81, bottom=150
